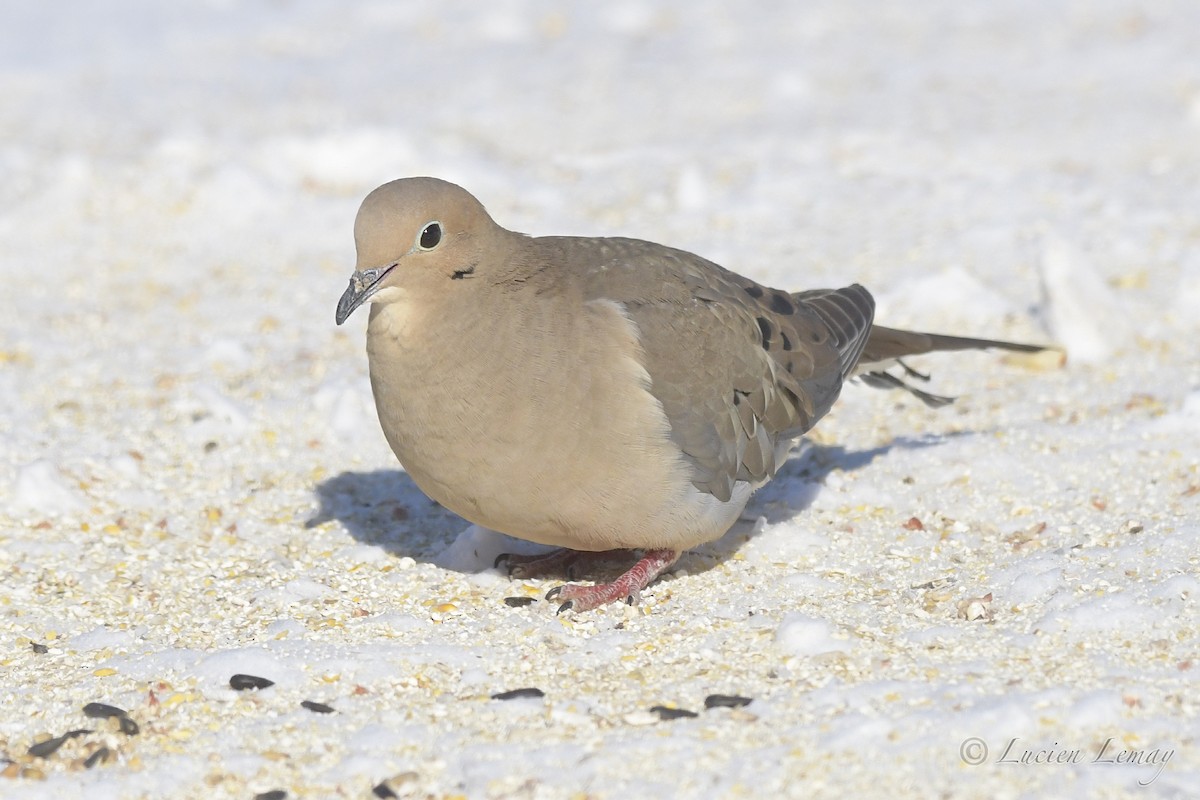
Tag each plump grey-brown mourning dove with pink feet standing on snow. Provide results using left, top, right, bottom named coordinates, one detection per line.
left=337, top=178, right=1043, bottom=612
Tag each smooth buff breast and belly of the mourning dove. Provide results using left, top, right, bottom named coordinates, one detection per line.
left=367, top=291, right=751, bottom=551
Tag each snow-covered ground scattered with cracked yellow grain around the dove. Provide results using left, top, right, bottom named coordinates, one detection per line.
left=0, top=0, right=1200, bottom=800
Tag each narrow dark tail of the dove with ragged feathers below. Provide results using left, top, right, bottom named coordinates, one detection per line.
left=853, top=325, right=1054, bottom=408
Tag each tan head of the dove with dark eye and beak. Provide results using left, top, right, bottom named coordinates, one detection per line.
left=337, top=178, right=508, bottom=325
